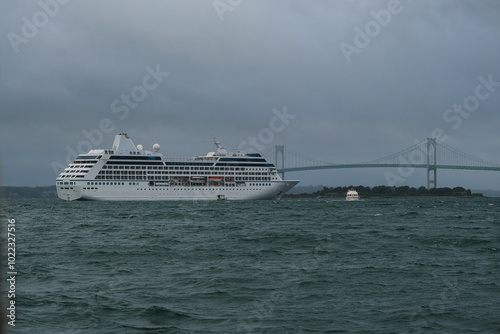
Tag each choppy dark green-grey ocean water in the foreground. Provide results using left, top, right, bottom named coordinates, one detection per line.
left=2, top=198, right=500, bottom=334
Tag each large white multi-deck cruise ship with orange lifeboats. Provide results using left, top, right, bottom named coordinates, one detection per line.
left=56, top=133, right=299, bottom=201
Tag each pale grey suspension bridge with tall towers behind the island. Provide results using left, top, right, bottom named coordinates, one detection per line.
left=264, top=138, right=500, bottom=188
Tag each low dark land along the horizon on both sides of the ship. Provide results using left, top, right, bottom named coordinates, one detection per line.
left=0, top=185, right=500, bottom=198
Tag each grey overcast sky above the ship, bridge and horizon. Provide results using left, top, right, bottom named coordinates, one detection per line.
left=0, top=0, right=500, bottom=189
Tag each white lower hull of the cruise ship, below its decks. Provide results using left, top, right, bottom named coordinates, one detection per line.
left=57, top=181, right=299, bottom=201
